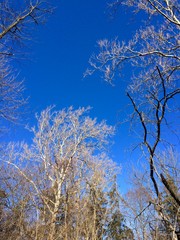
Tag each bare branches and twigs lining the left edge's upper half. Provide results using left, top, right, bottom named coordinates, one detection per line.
left=0, top=0, right=51, bottom=125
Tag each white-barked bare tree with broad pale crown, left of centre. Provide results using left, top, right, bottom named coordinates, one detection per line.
left=3, top=108, right=126, bottom=240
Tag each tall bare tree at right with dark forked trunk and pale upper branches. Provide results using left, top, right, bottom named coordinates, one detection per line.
left=86, top=0, right=180, bottom=239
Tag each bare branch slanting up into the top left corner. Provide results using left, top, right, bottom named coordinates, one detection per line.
left=0, top=0, right=52, bottom=51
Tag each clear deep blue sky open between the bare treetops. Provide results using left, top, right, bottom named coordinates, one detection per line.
left=7, top=0, right=149, bottom=191
